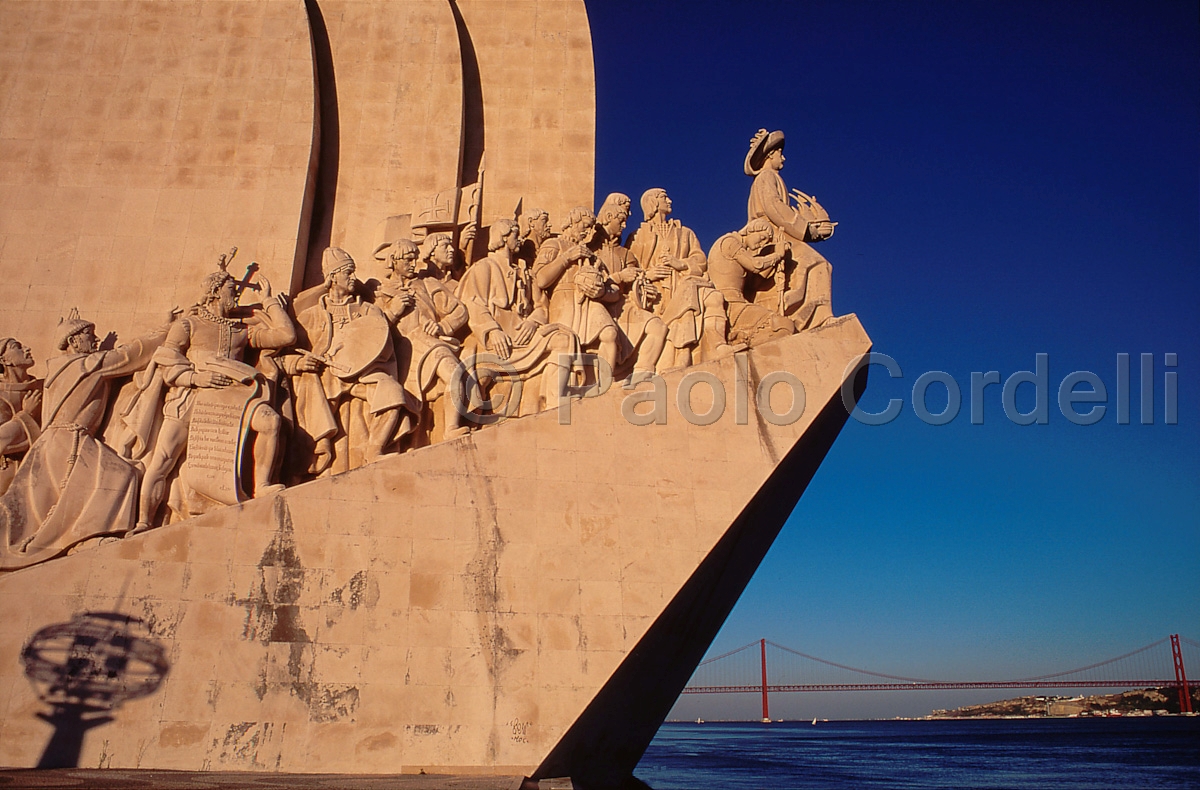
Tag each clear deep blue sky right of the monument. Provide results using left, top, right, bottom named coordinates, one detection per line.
left=589, top=0, right=1200, bottom=718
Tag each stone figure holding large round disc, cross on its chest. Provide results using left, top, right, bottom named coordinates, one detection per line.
left=281, top=247, right=420, bottom=474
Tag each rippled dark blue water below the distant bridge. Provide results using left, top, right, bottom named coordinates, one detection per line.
left=635, top=717, right=1200, bottom=790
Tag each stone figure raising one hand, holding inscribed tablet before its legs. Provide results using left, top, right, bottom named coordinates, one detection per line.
left=137, top=264, right=296, bottom=532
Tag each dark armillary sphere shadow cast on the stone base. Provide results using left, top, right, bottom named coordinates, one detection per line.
left=20, top=612, right=169, bottom=768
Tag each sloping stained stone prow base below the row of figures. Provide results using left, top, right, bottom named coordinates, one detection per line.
left=0, top=316, right=870, bottom=784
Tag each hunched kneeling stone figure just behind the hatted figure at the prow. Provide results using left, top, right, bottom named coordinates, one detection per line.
left=708, top=217, right=796, bottom=346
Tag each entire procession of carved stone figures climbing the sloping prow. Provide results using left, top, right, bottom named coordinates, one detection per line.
left=0, top=121, right=834, bottom=569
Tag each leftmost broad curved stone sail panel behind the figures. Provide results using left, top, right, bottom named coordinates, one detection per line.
left=0, top=0, right=313, bottom=360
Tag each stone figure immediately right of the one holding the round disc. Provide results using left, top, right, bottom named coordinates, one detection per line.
left=376, top=237, right=469, bottom=438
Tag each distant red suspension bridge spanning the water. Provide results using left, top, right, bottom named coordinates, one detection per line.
left=683, top=634, right=1200, bottom=719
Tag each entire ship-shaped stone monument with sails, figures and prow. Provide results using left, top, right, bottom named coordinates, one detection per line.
left=0, top=0, right=870, bottom=789
